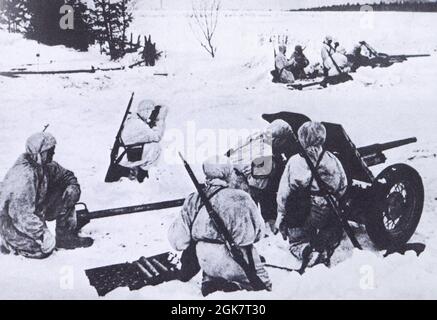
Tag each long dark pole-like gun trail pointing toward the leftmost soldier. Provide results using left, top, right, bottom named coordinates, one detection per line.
left=87, top=199, right=185, bottom=220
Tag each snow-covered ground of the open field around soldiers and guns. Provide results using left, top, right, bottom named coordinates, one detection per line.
left=0, top=8, right=437, bottom=299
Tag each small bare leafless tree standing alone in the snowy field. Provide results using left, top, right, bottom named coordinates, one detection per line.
left=190, top=0, right=221, bottom=58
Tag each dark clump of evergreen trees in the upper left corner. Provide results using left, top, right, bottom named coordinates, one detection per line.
left=0, top=0, right=138, bottom=60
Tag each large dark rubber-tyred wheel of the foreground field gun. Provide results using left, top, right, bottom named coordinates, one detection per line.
left=366, top=164, right=424, bottom=249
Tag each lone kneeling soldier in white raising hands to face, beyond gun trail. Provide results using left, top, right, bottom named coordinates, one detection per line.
left=121, top=100, right=167, bottom=183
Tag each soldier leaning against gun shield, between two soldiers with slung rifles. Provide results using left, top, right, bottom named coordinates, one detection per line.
left=228, top=120, right=293, bottom=225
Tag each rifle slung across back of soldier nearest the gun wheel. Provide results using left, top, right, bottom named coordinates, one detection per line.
left=292, top=132, right=362, bottom=250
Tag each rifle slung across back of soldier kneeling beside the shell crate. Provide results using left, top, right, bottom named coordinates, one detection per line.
left=179, top=152, right=266, bottom=291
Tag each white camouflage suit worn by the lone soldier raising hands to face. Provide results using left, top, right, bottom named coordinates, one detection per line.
left=121, top=100, right=168, bottom=170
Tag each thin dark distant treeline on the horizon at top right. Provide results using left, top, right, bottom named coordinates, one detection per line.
left=290, top=1, right=437, bottom=12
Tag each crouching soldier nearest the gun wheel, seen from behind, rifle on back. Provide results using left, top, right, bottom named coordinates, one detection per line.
left=274, top=122, right=347, bottom=266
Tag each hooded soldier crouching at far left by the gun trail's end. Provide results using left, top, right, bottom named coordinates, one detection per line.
left=0, top=132, right=93, bottom=259
